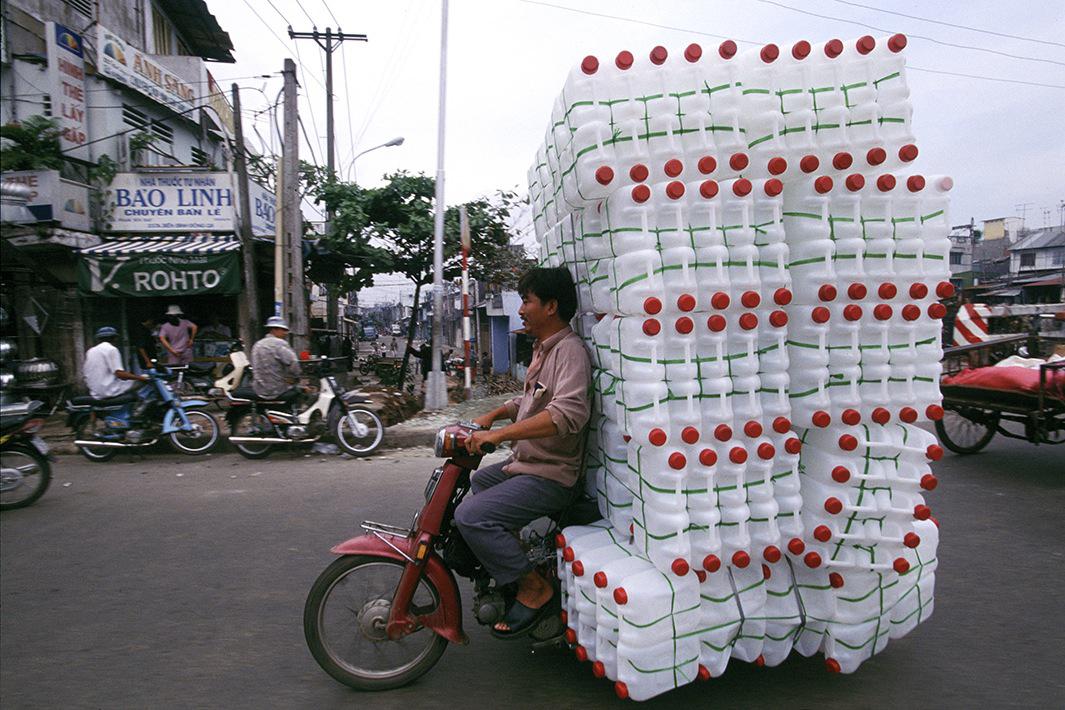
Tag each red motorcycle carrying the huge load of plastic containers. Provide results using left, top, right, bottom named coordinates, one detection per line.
left=304, top=423, right=600, bottom=690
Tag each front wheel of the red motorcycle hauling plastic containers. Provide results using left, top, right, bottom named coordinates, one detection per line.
left=304, top=555, right=447, bottom=691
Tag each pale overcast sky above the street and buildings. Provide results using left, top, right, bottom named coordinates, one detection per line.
left=208, top=0, right=1065, bottom=302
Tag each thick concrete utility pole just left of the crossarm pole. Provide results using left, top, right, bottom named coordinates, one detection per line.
left=281, top=59, right=310, bottom=351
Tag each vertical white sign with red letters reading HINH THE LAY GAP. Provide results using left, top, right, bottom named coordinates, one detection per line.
left=45, top=22, right=89, bottom=161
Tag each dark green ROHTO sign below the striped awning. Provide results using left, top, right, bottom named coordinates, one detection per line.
left=78, top=251, right=241, bottom=296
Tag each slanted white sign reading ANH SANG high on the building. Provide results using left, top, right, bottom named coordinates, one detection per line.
left=96, top=24, right=196, bottom=113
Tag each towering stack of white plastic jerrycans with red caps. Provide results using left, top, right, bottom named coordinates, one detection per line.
left=529, top=35, right=952, bottom=699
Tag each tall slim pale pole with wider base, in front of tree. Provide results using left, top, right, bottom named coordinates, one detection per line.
left=425, top=0, right=447, bottom=411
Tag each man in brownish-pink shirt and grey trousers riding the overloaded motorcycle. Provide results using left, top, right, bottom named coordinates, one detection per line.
left=455, top=268, right=591, bottom=638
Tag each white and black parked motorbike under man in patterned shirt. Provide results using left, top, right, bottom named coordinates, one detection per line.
left=226, top=358, right=384, bottom=459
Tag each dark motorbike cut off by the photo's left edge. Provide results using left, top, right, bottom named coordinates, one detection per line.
left=0, top=400, right=55, bottom=510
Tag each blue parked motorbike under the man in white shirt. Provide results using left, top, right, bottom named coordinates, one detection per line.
left=66, top=362, right=219, bottom=462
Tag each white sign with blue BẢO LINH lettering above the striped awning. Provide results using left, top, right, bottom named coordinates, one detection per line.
left=104, top=172, right=235, bottom=232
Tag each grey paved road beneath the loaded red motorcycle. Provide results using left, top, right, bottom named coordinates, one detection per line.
left=0, top=441, right=1065, bottom=709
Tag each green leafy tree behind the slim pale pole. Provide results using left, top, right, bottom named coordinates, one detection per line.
left=316, top=171, right=525, bottom=382
